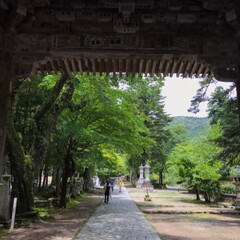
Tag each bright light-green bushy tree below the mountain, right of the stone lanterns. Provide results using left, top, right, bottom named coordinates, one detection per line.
left=168, top=125, right=223, bottom=201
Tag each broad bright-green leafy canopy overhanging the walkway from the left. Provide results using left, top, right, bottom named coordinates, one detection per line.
left=54, top=75, right=153, bottom=175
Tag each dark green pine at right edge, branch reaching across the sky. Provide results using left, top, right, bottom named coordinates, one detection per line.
left=189, top=77, right=240, bottom=167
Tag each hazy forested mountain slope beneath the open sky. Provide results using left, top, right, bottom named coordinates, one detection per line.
left=170, top=116, right=209, bottom=139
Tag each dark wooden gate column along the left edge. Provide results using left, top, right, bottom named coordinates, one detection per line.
left=0, top=33, right=13, bottom=177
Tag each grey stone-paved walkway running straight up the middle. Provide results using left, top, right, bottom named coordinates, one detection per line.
left=75, top=187, right=160, bottom=240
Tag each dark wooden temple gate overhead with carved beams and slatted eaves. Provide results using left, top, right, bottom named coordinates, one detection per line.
left=0, top=0, right=240, bottom=216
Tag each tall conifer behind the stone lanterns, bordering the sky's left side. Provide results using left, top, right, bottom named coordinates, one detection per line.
left=122, top=76, right=171, bottom=184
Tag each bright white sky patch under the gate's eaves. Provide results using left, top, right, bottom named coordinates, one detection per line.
left=162, top=77, right=235, bottom=117
